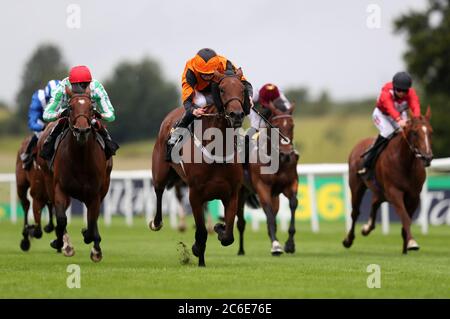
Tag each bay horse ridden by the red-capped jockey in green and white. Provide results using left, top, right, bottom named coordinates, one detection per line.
left=38, top=87, right=112, bottom=262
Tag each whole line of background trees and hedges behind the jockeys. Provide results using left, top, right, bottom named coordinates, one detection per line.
left=0, top=0, right=450, bottom=157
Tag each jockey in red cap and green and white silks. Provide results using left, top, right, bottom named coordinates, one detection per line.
left=40, top=65, right=119, bottom=160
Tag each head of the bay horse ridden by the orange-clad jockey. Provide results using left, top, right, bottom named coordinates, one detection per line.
left=212, top=69, right=245, bottom=128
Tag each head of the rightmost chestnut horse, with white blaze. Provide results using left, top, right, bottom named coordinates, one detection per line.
left=405, top=107, right=433, bottom=166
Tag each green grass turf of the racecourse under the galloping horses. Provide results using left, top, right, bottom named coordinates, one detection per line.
left=0, top=218, right=450, bottom=298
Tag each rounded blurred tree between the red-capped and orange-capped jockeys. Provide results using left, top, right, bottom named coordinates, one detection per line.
left=104, top=58, right=181, bottom=142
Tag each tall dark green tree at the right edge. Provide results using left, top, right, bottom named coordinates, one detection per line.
left=395, top=0, right=450, bottom=157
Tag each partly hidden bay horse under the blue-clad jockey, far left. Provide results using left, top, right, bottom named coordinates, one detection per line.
left=16, top=135, right=55, bottom=251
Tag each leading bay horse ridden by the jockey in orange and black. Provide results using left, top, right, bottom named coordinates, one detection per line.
left=153, top=69, right=245, bottom=267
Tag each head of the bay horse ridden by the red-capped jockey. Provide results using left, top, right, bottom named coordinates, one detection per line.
left=66, top=86, right=94, bottom=144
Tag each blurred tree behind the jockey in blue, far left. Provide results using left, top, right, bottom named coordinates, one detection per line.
left=14, top=44, right=67, bottom=131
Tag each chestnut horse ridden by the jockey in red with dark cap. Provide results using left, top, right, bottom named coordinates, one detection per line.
left=343, top=107, right=433, bottom=254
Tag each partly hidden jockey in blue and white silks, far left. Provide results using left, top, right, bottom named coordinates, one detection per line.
left=20, top=80, right=59, bottom=169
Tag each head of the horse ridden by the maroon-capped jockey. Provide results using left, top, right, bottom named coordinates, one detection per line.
left=269, top=104, right=295, bottom=163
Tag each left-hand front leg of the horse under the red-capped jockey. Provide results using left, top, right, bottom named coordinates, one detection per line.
left=50, top=184, right=75, bottom=257
